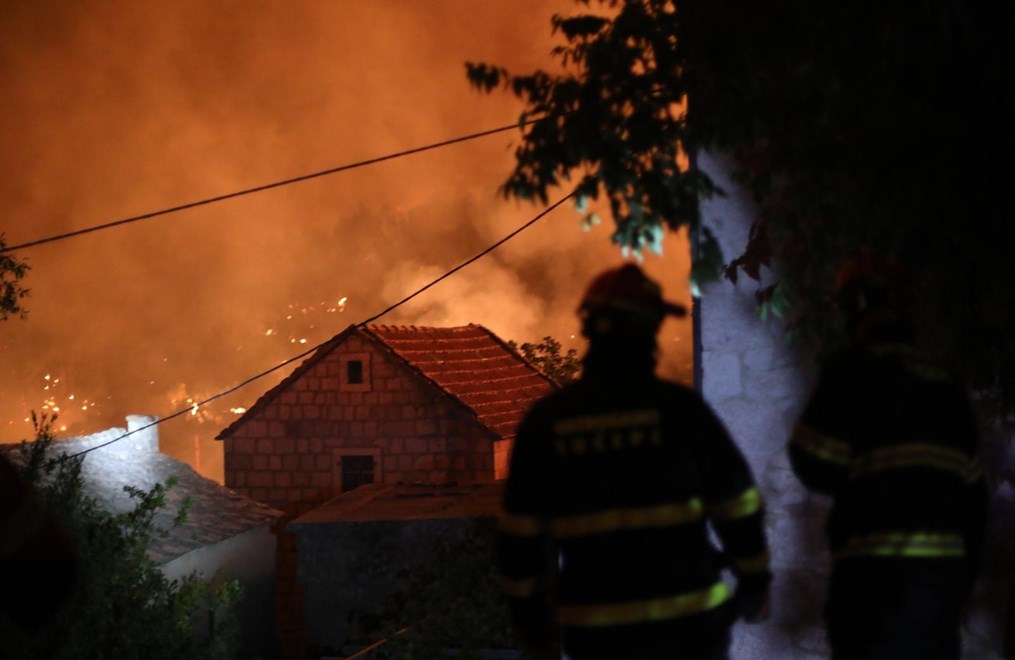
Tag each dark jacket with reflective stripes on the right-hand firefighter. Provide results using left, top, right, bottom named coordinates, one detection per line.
left=790, top=339, right=986, bottom=577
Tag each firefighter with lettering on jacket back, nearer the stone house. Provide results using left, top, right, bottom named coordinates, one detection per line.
left=499, top=264, right=770, bottom=660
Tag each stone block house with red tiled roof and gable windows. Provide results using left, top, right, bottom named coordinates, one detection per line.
left=217, top=325, right=555, bottom=513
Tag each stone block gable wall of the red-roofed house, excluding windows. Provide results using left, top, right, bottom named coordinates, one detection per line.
left=224, top=334, right=494, bottom=510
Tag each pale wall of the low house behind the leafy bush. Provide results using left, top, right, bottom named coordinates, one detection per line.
left=162, top=525, right=276, bottom=658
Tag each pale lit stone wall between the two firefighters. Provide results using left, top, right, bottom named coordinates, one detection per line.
left=696, top=150, right=840, bottom=660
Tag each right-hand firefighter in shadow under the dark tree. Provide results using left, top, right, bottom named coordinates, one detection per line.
left=789, top=251, right=987, bottom=660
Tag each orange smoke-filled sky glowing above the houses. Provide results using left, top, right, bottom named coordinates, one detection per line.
left=0, top=0, right=690, bottom=477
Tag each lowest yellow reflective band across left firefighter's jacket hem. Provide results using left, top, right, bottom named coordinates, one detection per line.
left=558, top=582, right=730, bottom=628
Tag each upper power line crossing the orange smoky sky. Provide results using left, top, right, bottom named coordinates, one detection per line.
left=0, top=119, right=541, bottom=254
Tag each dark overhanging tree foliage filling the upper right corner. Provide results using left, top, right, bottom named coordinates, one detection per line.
left=467, top=0, right=1015, bottom=400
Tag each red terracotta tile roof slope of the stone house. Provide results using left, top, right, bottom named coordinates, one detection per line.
left=363, top=324, right=556, bottom=438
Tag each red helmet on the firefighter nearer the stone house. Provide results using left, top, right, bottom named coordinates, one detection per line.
left=579, top=263, right=687, bottom=321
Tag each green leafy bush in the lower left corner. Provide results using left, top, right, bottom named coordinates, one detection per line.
left=0, top=417, right=240, bottom=660
